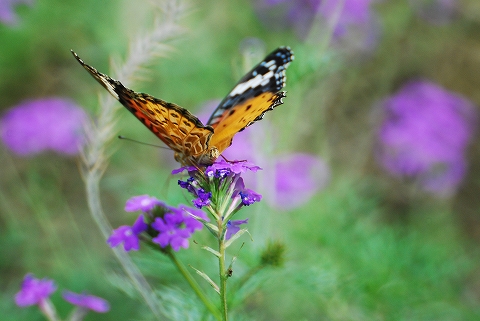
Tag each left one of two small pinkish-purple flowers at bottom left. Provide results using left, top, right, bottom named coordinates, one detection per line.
left=15, top=274, right=57, bottom=307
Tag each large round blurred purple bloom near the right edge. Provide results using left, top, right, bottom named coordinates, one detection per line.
left=377, top=80, right=476, bottom=195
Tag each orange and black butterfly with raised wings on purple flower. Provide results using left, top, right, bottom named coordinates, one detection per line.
left=72, top=47, right=294, bottom=167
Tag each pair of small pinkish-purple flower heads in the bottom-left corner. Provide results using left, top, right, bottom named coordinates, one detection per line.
left=15, top=274, right=110, bottom=320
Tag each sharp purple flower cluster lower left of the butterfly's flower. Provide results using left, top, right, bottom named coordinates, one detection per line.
left=107, top=195, right=208, bottom=251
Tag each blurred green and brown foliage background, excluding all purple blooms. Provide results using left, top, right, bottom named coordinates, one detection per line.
left=0, top=0, right=480, bottom=320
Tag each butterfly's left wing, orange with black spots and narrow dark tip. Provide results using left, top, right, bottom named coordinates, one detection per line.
left=72, top=51, right=214, bottom=165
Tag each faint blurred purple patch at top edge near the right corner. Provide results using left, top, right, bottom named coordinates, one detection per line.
left=409, top=0, right=458, bottom=25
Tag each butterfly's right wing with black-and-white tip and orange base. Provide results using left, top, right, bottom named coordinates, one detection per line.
left=207, top=47, right=294, bottom=153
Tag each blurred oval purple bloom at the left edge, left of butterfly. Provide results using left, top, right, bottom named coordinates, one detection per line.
left=0, top=98, right=87, bottom=155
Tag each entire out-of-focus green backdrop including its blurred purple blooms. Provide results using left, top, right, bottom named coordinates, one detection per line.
left=0, top=0, right=480, bottom=320
